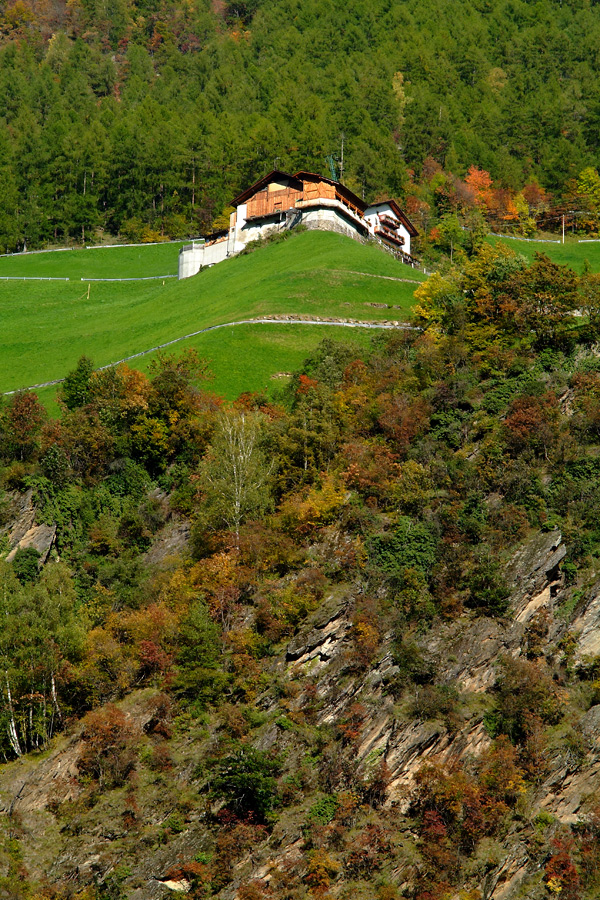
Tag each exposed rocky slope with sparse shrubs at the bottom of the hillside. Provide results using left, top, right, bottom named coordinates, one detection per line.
left=0, top=523, right=600, bottom=900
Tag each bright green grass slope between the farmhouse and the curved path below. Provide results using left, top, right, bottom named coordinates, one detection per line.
left=0, top=232, right=422, bottom=391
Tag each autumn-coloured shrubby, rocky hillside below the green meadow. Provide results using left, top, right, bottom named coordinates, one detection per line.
left=0, top=243, right=600, bottom=900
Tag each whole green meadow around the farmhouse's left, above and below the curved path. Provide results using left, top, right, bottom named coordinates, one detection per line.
left=0, top=231, right=423, bottom=398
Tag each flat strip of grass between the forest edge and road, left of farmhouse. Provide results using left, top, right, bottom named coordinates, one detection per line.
left=0, top=244, right=181, bottom=281
